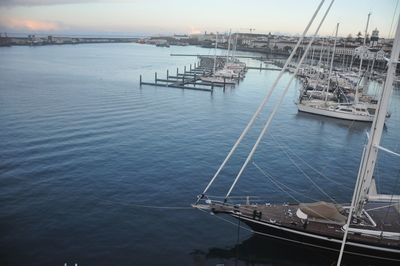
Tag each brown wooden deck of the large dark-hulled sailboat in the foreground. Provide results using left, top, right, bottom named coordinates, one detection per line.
left=209, top=203, right=400, bottom=249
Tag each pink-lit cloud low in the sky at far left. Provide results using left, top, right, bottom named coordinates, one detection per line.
left=0, top=18, right=64, bottom=31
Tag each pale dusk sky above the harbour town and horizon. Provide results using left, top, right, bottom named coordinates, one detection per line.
left=0, top=0, right=400, bottom=37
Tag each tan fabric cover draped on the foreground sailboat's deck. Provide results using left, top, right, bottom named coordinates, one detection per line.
left=299, top=201, right=347, bottom=224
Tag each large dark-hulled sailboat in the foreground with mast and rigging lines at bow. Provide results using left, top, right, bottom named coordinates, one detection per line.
left=193, top=0, right=400, bottom=265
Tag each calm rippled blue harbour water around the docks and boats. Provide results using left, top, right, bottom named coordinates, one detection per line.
left=0, top=44, right=400, bottom=265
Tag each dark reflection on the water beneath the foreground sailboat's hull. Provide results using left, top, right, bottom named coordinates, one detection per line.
left=191, top=235, right=395, bottom=266
